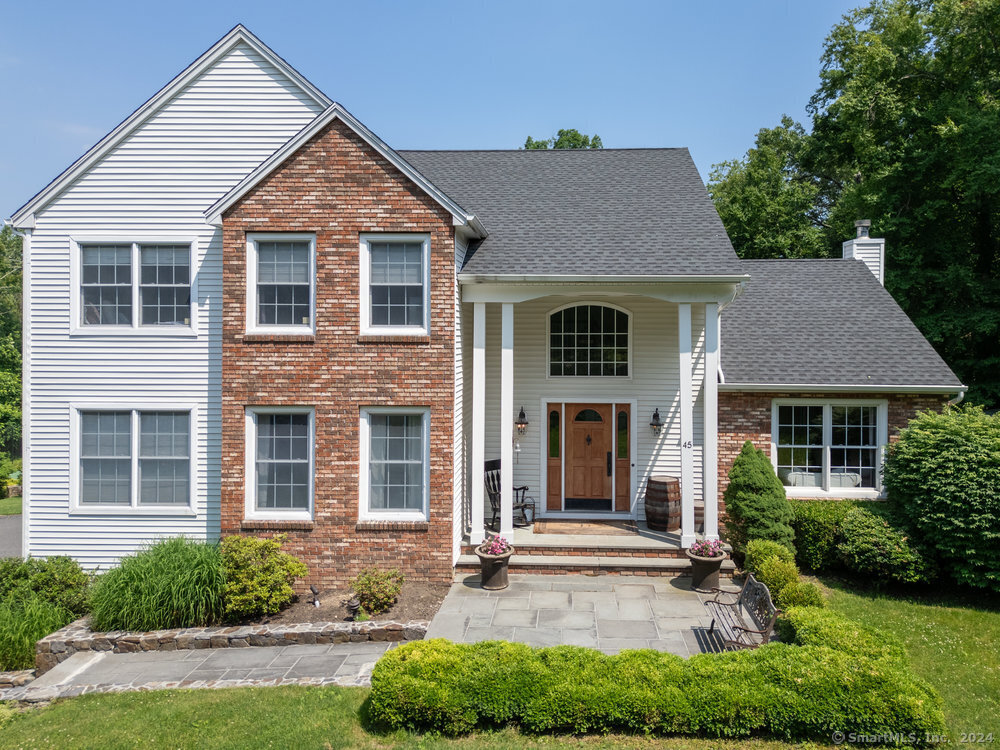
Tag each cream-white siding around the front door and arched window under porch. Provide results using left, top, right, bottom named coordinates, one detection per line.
left=472, top=296, right=714, bottom=518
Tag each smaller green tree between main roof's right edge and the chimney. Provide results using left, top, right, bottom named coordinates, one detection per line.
left=708, top=115, right=829, bottom=258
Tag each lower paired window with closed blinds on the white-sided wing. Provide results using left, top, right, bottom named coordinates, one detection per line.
left=71, top=406, right=193, bottom=512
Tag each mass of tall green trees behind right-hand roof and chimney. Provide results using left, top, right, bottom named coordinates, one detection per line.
left=713, top=0, right=1000, bottom=406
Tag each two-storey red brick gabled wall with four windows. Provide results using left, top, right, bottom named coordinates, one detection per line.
left=221, top=120, right=456, bottom=586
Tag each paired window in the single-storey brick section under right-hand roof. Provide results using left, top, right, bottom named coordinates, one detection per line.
left=771, top=399, right=888, bottom=497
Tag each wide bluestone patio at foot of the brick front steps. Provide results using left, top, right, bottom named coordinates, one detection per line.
left=426, top=575, right=738, bottom=657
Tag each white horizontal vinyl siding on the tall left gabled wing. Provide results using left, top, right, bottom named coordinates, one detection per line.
left=24, top=42, right=321, bottom=569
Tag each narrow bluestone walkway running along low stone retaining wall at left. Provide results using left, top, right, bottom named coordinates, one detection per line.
left=0, top=642, right=397, bottom=701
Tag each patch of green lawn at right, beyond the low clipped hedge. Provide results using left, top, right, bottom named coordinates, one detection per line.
left=824, top=581, right=1000, bottom=743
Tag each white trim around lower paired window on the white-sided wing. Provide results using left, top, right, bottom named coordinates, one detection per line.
left=69, top=401, right=198, bottom=516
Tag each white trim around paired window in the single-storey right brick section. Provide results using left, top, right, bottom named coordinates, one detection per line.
left=771, top=398, right=889, bottom=499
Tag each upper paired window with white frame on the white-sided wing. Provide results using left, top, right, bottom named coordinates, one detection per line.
left=72, top=240, right=194, bottom=333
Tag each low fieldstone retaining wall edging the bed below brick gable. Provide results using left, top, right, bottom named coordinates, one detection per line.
left=35, top=617, right=430, bottom=675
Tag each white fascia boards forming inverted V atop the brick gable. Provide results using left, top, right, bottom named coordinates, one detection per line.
left=205, top=102, right=486, bottom=237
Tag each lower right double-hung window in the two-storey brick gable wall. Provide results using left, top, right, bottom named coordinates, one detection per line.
left=359, top=407, right=430, bottom=521
